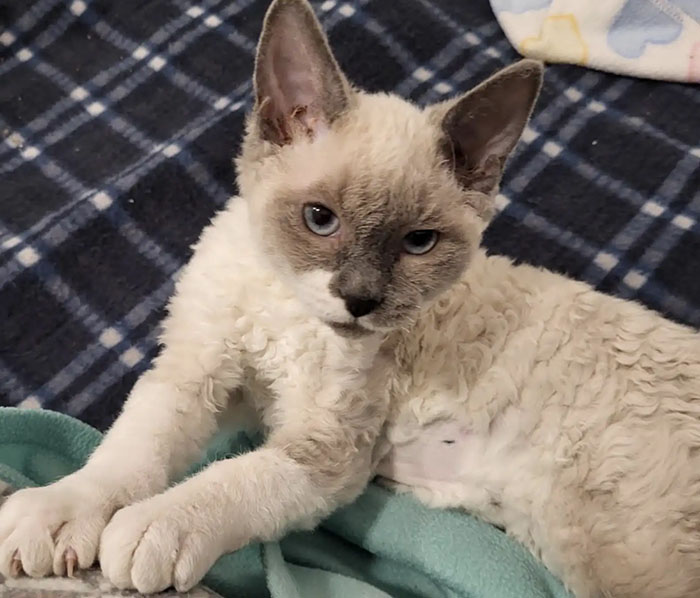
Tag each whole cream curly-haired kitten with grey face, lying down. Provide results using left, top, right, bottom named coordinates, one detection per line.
left=0, top=0, right=700, bottom=598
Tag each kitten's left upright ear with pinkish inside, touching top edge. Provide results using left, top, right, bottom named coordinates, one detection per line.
left=254, top=0, right=351, bottom=145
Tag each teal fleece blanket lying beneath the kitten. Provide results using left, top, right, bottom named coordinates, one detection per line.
left=0, top=408, right=569, bottom=598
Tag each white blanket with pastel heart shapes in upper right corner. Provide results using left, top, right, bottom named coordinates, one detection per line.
left=491, top=0, right=700, bottom=83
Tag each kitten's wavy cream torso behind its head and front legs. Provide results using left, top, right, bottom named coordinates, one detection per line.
left=379, top=248, right=700, bottom=598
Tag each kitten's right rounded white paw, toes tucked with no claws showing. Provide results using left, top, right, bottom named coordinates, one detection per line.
left=100, top=493, right=224, bottom=594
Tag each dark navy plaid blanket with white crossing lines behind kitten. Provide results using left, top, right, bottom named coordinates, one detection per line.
left=0, top=0, right=700, bottom=428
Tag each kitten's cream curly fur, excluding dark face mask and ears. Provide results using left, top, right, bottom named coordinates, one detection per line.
left=0, top=2, right=700, bottom=598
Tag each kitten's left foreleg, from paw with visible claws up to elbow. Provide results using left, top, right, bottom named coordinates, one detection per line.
left=0, top=356, right=238, bottom=577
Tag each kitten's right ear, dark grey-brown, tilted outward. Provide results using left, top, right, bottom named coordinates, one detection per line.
left=431, top=60, right=543, bottom=194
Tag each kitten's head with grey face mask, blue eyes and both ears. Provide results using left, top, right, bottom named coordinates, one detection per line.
left=236, top=0, right=542, bottom=335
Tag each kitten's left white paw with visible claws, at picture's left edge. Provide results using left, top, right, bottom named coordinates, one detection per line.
left=0, top=478, right=109, bottom=577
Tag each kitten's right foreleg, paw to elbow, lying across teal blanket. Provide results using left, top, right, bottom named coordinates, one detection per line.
left=100, top=390, right=383, bottom=593
